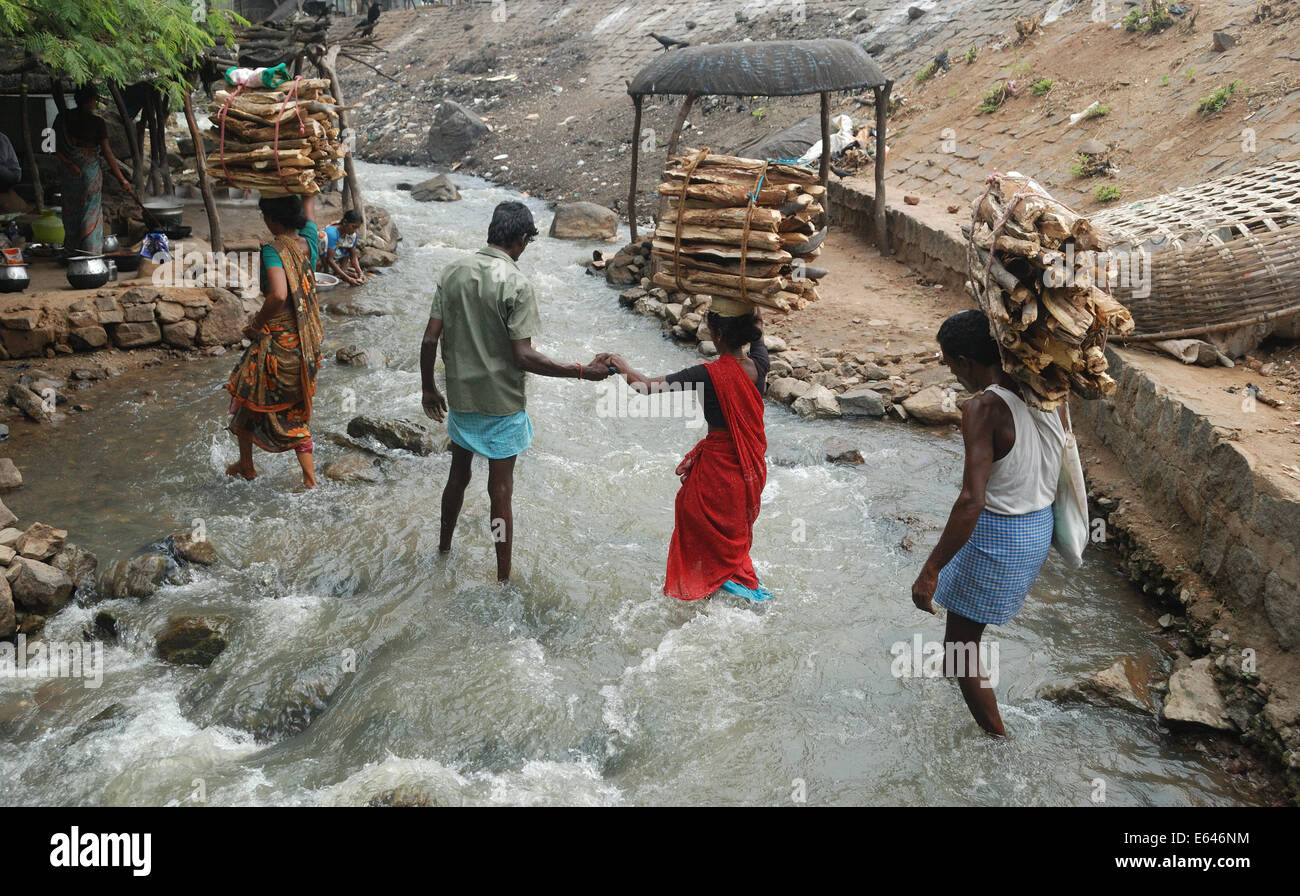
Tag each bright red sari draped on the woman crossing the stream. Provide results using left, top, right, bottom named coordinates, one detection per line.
left=663, top=355, right=767, bottom=601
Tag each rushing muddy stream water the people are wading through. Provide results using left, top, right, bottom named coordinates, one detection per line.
left=0, top=160, right=1252, bottom=805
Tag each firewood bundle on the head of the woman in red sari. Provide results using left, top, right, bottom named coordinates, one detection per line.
left=653, top=147, right=826, bottom=313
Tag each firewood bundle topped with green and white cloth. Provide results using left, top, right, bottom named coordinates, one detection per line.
left=205, top=78, right=346, bottom=196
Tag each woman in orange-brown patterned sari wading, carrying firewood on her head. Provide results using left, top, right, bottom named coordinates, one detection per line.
left=226, top=196, right=324, bottom=489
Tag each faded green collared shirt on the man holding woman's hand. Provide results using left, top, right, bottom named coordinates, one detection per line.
left=429, top=246, right=542, bottom=417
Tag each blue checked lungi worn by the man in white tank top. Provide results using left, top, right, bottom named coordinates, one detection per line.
left=935, top=506, right=1053, bottom=626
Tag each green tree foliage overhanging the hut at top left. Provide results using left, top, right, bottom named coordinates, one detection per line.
left=0, top=0, right=247, bottom=98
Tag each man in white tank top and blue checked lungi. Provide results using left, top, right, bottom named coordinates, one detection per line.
left=911, top=311, right=1065, bottom=737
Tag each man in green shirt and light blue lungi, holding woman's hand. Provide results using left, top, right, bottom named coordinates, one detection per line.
left=420, top=202, right=610, bottom=581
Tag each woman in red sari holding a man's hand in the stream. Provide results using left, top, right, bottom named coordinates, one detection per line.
left=607, top=305, right=772, bottom=601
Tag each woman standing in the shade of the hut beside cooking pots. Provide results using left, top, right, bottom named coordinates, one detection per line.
left=55, top=85, right=131, bottom=255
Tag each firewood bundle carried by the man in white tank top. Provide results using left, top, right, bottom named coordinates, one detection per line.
left=967, top=172, right=1134, bottom=411
